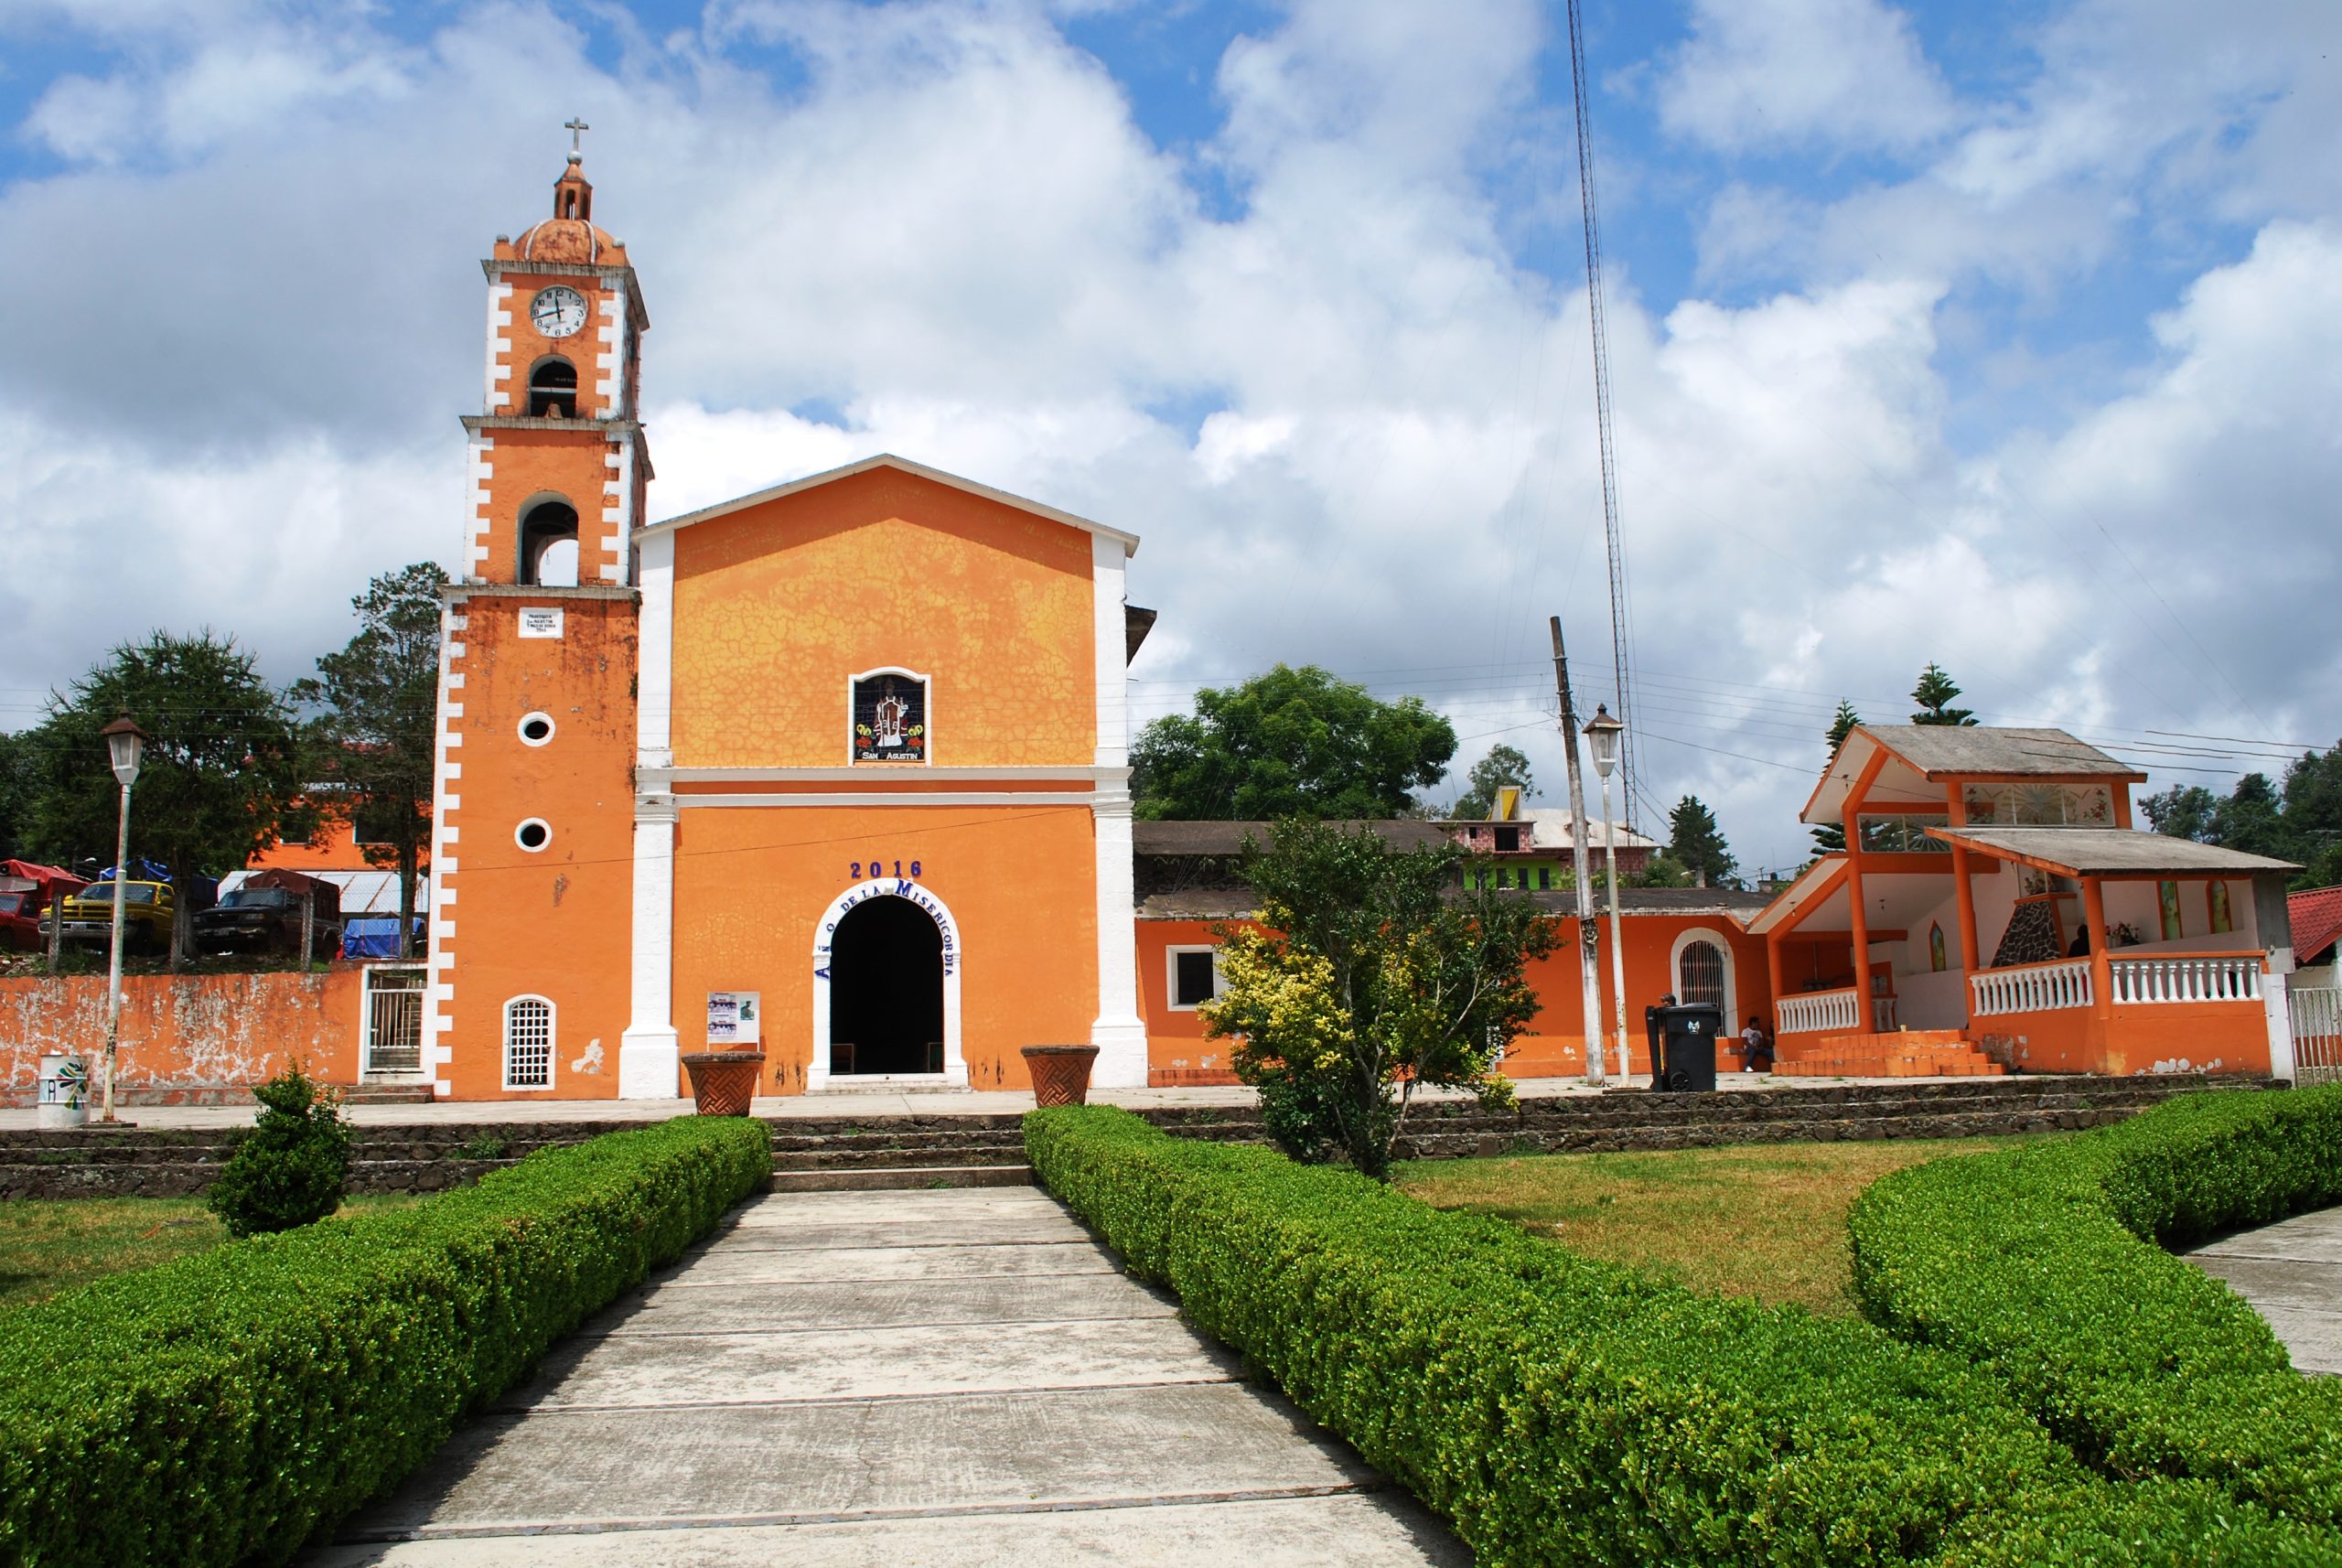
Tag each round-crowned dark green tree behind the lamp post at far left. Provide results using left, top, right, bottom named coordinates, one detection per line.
left=33, top=632, right=300, bottom=967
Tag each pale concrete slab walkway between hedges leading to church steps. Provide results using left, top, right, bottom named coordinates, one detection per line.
left=309, top=1189, right=1471, bottom=1568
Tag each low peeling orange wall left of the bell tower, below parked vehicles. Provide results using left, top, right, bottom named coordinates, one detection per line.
left=0, top=964, right=365, bottom=1104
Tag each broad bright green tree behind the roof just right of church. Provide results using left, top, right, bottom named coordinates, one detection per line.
left=1131, top=665, right=1456, bottom=822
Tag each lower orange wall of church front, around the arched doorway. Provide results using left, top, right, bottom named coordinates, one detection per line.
left=674, top=805, right=1099, bottom=1093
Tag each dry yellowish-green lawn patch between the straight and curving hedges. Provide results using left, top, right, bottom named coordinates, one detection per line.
left=1396, top=1133, right=2057, bottom=1316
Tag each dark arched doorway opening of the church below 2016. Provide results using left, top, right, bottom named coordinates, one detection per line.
left=829, top=897, right=944, bottom=1074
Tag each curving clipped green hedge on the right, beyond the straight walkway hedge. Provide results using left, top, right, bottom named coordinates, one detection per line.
left=1850, top=1086, right=2342, bottom=1529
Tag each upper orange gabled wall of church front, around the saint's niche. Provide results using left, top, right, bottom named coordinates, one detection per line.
left=665, top=470, right=1099, bottom=781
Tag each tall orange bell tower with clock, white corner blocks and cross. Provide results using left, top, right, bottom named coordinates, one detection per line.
left=424, top=137, right=650, bottom=1100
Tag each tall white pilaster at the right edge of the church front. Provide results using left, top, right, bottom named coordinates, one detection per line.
left=1089, top=533, right=1147, bottom=1089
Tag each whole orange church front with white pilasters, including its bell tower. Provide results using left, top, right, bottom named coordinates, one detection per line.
left=424, top=155, right=1147, bottom=1100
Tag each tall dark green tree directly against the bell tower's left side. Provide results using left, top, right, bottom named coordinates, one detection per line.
left=288, top=562, right=447, bottom=957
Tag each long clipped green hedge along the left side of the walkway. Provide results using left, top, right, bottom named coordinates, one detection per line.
left=0, top=1116, right=773, bottom=1568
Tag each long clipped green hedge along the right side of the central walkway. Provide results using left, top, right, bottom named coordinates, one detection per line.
left=1026, top=1107, right=2333, bottom=1568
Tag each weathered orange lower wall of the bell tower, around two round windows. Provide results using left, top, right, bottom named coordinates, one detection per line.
left=426, top=595, right=635, bottom=1100
